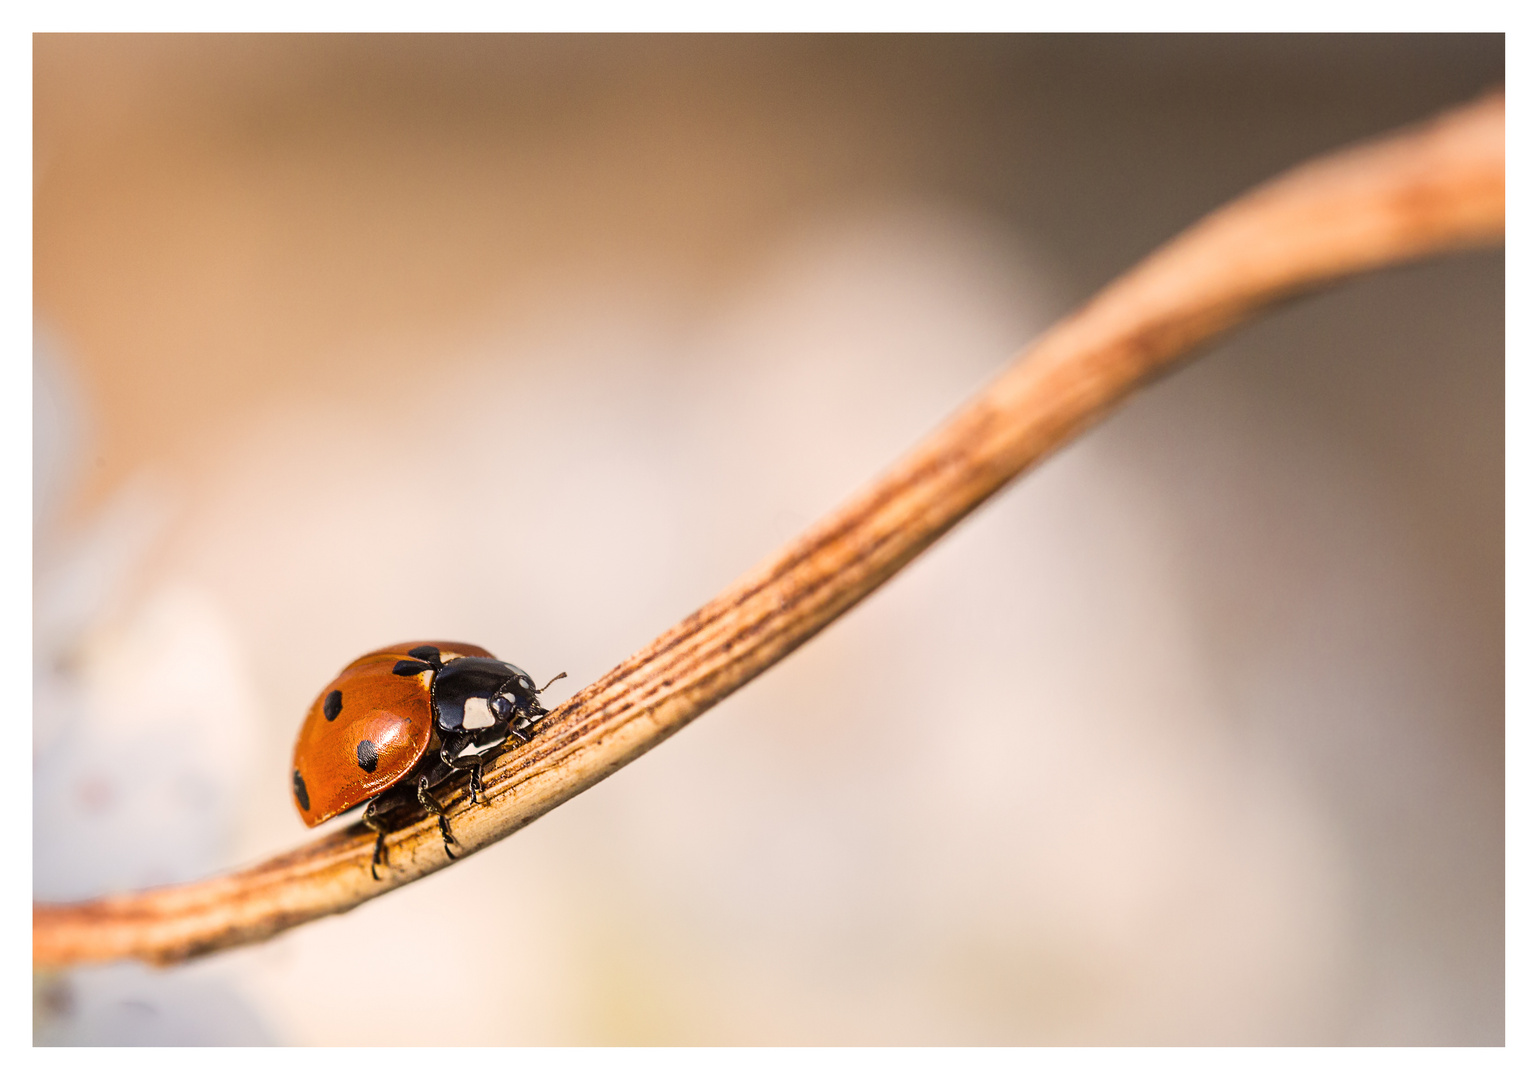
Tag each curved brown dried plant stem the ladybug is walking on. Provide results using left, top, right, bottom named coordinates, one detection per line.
left=32, top=94, right=1506, bottom=965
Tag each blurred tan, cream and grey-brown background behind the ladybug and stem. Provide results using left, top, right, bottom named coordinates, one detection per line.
left=32, top=35, right=1504, bottom=1045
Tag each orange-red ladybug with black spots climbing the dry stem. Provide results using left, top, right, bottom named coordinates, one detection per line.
left=294, top=642, right=566, bottom=880
